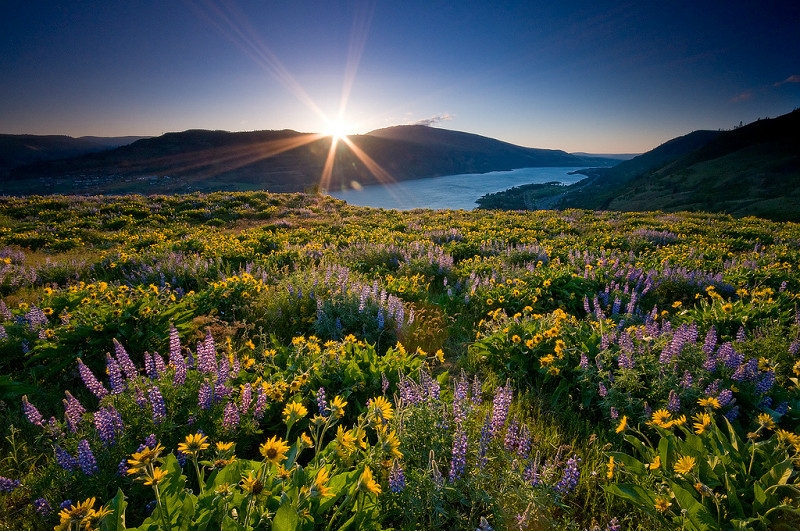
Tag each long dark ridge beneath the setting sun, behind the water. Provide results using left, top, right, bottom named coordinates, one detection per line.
left=0, top=126, right=617, bottom=195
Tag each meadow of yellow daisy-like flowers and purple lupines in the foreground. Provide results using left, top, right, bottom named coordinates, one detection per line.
left=0, top=192, right=800, bottom=531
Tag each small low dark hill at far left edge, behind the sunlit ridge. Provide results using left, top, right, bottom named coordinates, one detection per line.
left=0, top=134, right=143, bottom=175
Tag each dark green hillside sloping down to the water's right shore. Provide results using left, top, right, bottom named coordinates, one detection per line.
left=480, top=109, right=800, bottom=221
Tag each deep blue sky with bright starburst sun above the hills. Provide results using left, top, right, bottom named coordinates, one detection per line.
left=0, top=0, right=800, bottom=153
